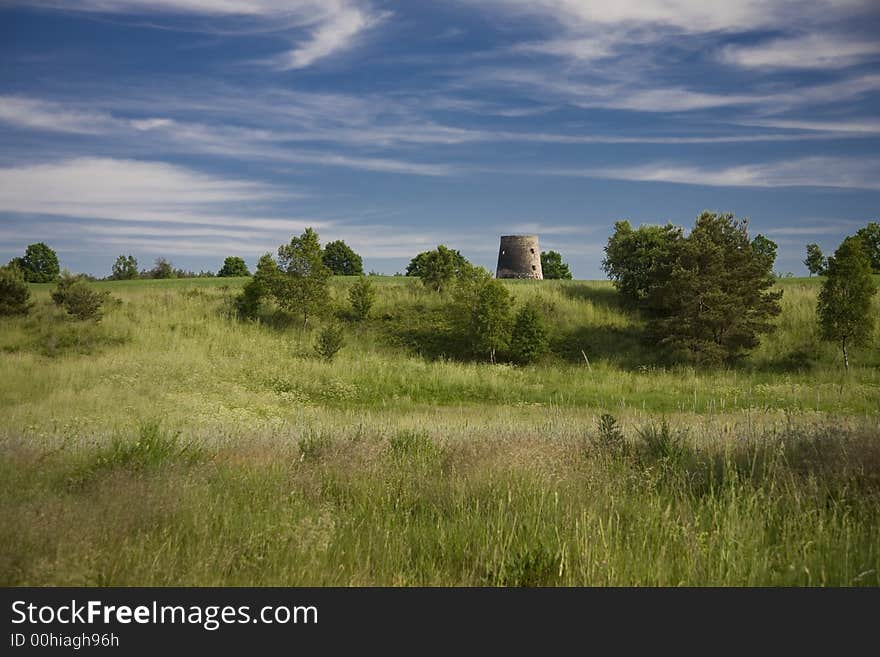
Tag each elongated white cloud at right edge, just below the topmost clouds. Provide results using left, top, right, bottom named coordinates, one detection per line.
left=720, top=33, right=880, bottom=69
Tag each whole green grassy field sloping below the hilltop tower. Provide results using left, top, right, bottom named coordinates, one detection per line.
left=0, top=277, right=880, bottom=586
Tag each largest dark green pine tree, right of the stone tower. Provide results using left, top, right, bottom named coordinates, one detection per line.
left=646, top=212, right=782, bottom=363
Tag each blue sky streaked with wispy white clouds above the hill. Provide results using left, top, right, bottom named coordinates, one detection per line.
left=0, top=0, right=880, bottom=278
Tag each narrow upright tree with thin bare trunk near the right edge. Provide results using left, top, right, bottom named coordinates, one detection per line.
left=816, top=237, right=877, bottom=369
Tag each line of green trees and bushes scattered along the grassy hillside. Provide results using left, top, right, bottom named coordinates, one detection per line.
left=0, top=217, right=880, bottom=367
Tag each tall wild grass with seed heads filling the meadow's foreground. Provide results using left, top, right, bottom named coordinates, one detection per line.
left=0, top=426, right=880, bottom=586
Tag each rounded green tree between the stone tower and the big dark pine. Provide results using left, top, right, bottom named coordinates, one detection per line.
left=602, top=221, right=682, bottom=306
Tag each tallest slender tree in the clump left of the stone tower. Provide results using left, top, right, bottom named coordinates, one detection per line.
left=273, top=228, right=330, bottom=326
